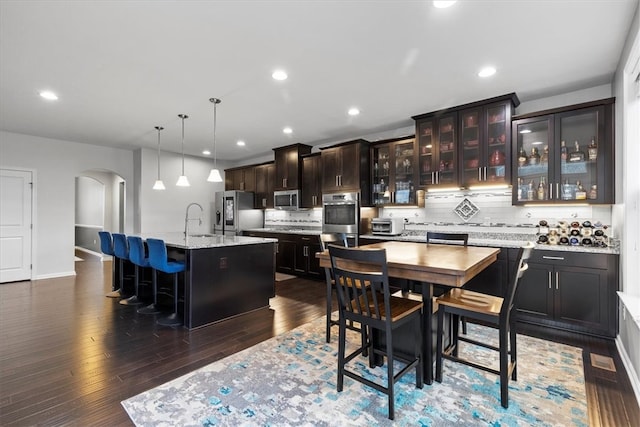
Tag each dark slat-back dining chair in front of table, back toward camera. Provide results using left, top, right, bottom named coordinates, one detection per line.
left=329, top=245, right=423, bottom=420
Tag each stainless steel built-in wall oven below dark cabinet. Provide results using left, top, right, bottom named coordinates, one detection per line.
left=322, top=193, right=360, bottom=244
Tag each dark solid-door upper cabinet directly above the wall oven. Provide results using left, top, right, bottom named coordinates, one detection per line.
left=321, top=139, right=370, bottom=202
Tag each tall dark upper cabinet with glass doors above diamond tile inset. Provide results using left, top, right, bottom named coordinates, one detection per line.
left=413, top=93, right=520, bottom=188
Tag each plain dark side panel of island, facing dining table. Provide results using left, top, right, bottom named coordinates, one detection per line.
left=185, top=243, right=275, bottom=329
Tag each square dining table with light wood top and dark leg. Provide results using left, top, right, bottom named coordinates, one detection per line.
left=316, top=241, right=500, bottom=384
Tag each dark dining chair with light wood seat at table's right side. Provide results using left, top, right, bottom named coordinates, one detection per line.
left=435, top=242, right=534, bottom=408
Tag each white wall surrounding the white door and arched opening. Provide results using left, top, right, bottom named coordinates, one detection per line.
left=0, top=132, right=133, bottom=279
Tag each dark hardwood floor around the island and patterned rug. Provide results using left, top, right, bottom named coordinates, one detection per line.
left=0, top=253, right=640, bottom=426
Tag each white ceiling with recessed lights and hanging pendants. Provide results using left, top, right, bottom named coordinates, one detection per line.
left=0, top=0, right=638, bottom=161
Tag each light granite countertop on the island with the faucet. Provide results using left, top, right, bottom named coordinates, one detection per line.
left=141, top=232, right=278, bottom=249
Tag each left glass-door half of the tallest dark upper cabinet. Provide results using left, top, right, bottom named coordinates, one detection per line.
left=416, top=113, right=459, bottom=187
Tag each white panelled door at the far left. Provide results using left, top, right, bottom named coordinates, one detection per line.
left=0, top=169, right=32, bottom=283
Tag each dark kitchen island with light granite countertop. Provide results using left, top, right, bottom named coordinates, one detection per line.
left=142, top=233, right=277, bottom=329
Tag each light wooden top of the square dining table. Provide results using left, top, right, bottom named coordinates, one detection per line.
left=316, top=241, right=500, bottom=287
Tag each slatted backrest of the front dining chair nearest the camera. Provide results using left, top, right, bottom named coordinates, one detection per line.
left=329, top=245, right=391, bottom=324
